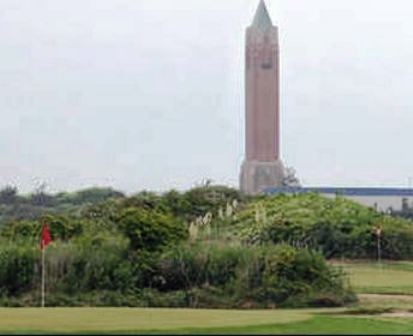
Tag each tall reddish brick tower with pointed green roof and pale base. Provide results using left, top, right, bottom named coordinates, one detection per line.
left=240, top=0, right=285, bottom=194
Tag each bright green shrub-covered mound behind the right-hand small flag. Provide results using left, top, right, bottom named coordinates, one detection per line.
left=233, top=194, right=413, bottom=260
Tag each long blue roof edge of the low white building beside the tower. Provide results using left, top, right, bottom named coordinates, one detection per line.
left=264, top=187, right=413, bottom=197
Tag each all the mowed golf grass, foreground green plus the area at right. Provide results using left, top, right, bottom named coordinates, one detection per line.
left=0, top=262, right=413, bottom=334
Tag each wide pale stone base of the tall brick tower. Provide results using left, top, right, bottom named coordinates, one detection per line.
left=240, top=160, right=285, bottom=195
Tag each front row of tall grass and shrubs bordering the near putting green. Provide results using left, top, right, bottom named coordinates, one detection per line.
left=0, top=242, right=355, bottom=308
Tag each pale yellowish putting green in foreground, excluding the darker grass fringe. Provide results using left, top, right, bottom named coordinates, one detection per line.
left=0, top=308, right=311, bottom=333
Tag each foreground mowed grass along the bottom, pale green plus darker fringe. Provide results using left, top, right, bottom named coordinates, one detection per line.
left=0, top=308, right=413, bottom=334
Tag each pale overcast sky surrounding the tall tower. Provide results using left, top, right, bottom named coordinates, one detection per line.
left=0, top=0, right=413, bottom=192
